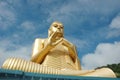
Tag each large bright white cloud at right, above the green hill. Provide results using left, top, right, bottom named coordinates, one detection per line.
left=82, top=42, right=120, bottom=69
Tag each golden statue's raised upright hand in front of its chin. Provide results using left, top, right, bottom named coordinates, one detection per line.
left=48, top=31, right=63, bottom=47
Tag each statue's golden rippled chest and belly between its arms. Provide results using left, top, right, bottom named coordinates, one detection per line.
left=42, top=45, right=73, bottom=69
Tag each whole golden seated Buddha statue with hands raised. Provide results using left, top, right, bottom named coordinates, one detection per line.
left=2, top=22, right=116, bottom=77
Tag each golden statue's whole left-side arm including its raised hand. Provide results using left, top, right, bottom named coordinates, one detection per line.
left=31, top=32, right=63, bottom=63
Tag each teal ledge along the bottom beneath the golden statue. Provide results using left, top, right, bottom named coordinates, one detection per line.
left=0, top=69, right=120, bottom=80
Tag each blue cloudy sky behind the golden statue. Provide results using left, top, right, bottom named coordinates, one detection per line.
left=0, top=0, right=120, bottom=69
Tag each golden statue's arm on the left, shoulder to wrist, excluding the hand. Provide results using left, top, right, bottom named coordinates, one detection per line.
left=31, top=39, right=51, bottom=63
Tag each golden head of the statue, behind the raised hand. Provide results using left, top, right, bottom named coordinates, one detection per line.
left=48, top=21, right=64, bottom=37
